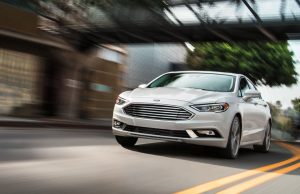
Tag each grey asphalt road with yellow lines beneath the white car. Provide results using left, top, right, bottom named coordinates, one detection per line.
left=0, top=128, right=300, bottom=194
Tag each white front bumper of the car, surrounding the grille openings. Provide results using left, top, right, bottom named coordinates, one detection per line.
left=112, top=101, right=233, bottom=148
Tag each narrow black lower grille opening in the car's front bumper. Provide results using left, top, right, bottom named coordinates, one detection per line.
left=124, top=125, right=190, bottom=138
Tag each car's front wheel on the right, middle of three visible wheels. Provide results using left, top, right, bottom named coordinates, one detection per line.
left=223, top=116, right=241, bottom=159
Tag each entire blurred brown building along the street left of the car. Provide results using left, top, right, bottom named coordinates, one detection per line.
left=0, top=1, right=126, bottom=119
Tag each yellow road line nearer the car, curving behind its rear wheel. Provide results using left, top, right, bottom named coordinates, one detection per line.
left=175, top=143, right=300, bottom=194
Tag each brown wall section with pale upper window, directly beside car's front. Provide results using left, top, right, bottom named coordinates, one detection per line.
left=80, top=45, right=126, bottom=120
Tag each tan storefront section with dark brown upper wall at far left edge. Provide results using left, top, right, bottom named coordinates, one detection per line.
left=0, top=3, right=51, bottom=117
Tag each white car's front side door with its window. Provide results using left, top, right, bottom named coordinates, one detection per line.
left=238, top=77, right=258, bottom=143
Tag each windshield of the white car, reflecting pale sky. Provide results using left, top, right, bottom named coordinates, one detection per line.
left=148, top=73, right=235, bottom=92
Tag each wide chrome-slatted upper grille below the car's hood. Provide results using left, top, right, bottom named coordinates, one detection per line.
left=124, top=104, right=193, bottom=120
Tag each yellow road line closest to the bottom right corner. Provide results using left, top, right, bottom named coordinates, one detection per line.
left=217, top=162, right=300, bottom=194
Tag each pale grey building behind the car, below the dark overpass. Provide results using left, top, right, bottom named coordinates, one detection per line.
left=125, top=44, right=187, bottom=89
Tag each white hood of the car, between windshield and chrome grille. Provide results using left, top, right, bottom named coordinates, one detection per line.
left=129, top=87, right=229, bottom=103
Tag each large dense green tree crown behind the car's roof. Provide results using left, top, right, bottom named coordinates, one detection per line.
left=187, top=42, right=297, bottom=86
